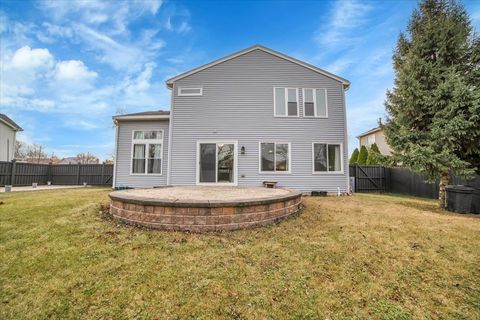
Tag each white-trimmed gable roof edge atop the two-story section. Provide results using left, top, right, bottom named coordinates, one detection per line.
left=166, top=45, right=350, bottom=89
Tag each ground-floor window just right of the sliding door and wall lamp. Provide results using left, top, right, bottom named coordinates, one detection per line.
left=260, top=142, right=290, bottom=173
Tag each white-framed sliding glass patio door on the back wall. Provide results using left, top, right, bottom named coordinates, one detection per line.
left=197, top=141, right=237, bottom=185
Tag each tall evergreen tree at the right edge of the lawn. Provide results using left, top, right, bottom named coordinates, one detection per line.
left=384, top=0, right=480, bottom=206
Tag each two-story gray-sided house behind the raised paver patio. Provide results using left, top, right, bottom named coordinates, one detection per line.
left=113, top=45, right=350, bottom=192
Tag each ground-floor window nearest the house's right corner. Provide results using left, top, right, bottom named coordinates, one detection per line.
left=312, top=143, right=343, bottom=173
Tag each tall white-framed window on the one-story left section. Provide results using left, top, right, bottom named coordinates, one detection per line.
left=132, top=130, right=163, bottom=174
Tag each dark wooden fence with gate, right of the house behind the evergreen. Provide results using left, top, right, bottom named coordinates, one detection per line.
left=350, top=165, right=480, bottom=199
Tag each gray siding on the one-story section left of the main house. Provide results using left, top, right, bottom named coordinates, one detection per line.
left=114, top=120, right=168, bottom=188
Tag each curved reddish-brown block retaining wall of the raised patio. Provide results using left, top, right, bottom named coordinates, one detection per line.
left=110, top=191, right=302, bottom=232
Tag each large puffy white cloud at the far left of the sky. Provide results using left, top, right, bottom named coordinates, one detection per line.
left=0, top=46, right=102, bottom=112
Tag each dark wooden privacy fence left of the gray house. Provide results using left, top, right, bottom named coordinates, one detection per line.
left=0, top=161, right=113, bottom=186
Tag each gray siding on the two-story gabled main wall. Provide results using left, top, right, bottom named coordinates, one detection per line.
left=170, top=50, right=348, bottom=192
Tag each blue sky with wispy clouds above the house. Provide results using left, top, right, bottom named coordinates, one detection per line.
left=0, top=0, right=480, bottom=160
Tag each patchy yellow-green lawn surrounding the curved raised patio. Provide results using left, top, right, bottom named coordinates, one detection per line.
left=0, top=188, right=480, bottom=319
